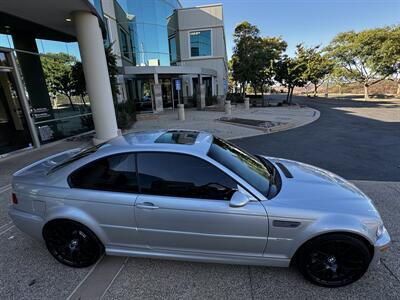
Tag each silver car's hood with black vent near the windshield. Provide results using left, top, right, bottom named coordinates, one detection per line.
left=266, top=157, right=379, bottom=216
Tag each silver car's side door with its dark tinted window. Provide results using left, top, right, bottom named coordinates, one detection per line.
left=135, top=152, right=268, bottom=256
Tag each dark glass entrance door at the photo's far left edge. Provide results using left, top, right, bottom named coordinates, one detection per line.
left=0, top=52, right=32, bottom=155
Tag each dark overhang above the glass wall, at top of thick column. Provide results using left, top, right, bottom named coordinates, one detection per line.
left=0, top=0, right=104, bottom=42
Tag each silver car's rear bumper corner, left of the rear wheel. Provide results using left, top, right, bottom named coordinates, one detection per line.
left=8, top=206, right=44, bottom=240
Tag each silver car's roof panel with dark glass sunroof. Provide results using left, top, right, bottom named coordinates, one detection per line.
left=98, top=129, right=213, bottom=154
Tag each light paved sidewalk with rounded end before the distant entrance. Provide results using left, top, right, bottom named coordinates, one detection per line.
left=129, top=105, right=320, bottom=139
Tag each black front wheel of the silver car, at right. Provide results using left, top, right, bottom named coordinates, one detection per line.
left=297, top=234, right=372, bottom=288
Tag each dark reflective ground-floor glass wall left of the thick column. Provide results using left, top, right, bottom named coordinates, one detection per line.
left=0, top=34, right=94, bottom=155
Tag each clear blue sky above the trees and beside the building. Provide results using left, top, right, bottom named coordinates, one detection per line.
left=181, top=0, right=400, bottom=57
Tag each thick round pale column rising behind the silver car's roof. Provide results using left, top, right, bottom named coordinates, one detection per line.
left=72, top=11, right=118, bottom=143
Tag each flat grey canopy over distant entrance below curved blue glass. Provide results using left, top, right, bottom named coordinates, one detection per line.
left=124, top=66, right=217, bottom=76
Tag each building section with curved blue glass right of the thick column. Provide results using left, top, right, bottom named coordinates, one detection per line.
left=101, top=0, right=227, bottom=113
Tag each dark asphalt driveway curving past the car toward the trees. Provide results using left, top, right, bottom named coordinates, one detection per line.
left=233, top=97, right=400, bottom=181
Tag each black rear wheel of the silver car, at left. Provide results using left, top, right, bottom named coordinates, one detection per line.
left=43, top=220, right=104, bottom=268
